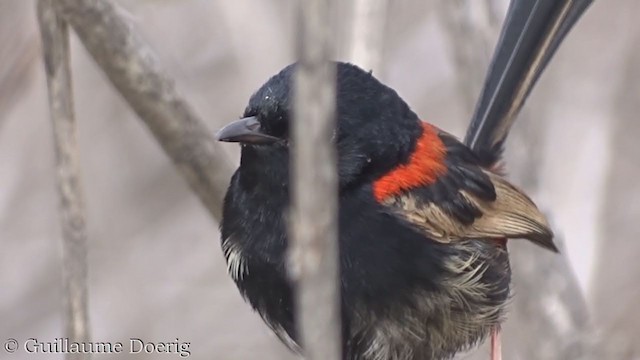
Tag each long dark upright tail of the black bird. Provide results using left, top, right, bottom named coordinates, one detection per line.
left=464, top=0, right=592, bottom=164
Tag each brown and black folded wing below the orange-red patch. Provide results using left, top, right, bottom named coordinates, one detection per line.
left=383, top=132, right=557, bottom=251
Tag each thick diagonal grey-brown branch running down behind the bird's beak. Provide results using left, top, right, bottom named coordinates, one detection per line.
left=54, top=0, right=233, bottom=219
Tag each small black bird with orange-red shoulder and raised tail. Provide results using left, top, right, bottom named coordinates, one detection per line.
left=217, top=0, right=586, bottom=360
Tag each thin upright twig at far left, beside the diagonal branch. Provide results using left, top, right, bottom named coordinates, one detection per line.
left=38, top=0, right=90, bottom=360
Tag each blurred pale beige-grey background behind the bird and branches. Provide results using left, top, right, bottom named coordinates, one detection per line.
left=0, top=0, right=640, bottom=360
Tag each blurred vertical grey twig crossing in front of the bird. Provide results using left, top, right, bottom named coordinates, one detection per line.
left=290, top=0, right=342, bottom=360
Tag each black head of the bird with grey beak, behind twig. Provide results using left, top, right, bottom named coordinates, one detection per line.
left=217, top=63, right=422, bottom=188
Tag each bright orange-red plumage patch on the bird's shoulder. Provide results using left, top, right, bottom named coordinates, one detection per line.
left=373, top=122, right=447, bottom=202
